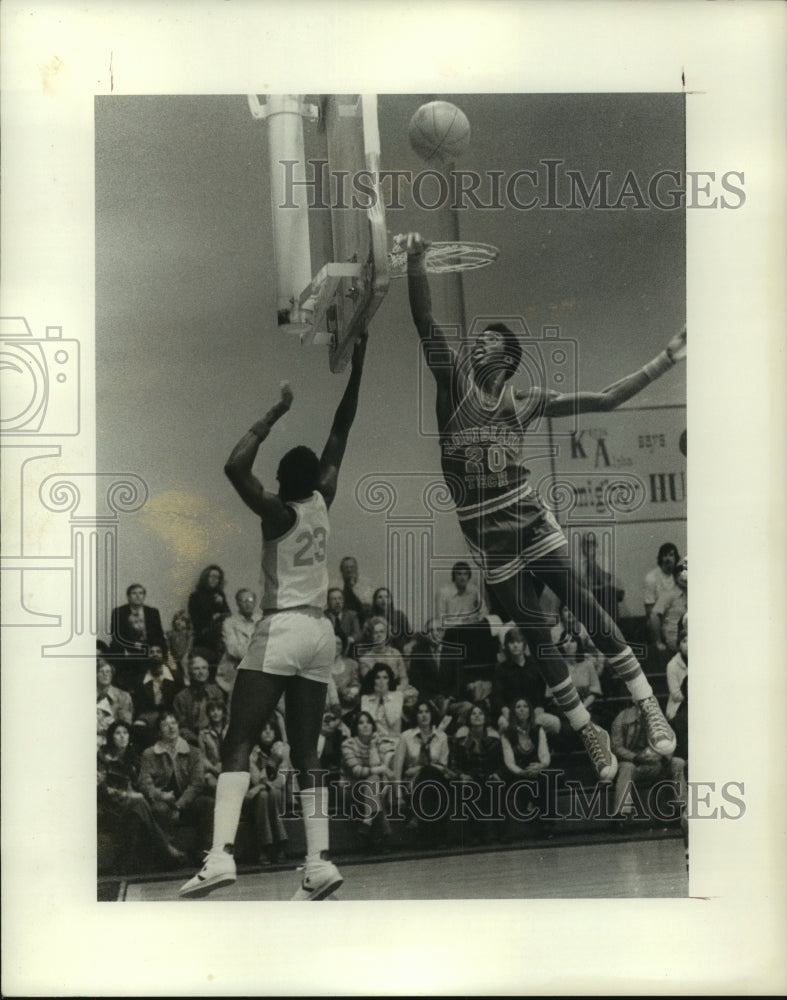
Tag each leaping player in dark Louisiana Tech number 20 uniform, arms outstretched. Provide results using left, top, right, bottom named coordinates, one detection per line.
left=404, top=233, right=686, bottom=780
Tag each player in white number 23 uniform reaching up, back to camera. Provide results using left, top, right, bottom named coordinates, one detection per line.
left=180, top=334, right=366, bottom=900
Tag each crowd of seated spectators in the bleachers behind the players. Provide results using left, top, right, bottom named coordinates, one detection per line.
left=96, top=540, right=688, bottom=870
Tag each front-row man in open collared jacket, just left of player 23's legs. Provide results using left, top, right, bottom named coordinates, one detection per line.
left=139, top=710, right=213, bottom=862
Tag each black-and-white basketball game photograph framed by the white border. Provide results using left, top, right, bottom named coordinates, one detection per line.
left=96, top=93, right=688, bottom=901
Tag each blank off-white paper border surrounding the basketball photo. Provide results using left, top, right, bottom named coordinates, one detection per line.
left=0, top=0, right=787, bottom=996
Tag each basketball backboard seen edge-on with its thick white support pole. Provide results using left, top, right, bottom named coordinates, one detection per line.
left=248, top=94, right=389, bottom=372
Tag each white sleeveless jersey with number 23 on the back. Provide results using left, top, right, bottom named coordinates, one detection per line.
left=260, top=492, right=330, bottom=611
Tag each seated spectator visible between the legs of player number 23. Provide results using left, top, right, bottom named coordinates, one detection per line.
left=244, top=719, right=292, bottom=865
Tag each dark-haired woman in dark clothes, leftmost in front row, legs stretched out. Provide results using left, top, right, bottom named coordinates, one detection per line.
left=98, top=719, right=186, bottom=873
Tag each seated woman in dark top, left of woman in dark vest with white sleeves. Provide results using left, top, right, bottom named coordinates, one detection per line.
left=451, top=704, right=503, bottom=842
